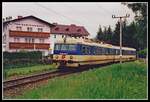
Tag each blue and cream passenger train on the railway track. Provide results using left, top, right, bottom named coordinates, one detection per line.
left=53, top=38, right=136, bottom=68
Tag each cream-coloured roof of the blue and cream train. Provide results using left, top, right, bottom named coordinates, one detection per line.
left=56, top=38, right=136, bottom=51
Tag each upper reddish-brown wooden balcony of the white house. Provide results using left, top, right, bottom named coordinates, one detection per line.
left=9, top=30, right=50, bottom=38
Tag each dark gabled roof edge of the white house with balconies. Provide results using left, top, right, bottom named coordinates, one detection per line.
left=3, top=15, right=55, bottom=27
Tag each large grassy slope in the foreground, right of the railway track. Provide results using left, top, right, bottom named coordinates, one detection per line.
left=10, top=61, right=147, bottom=99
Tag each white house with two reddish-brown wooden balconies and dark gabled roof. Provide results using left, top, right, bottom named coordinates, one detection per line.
left=3, top=16, right=54, bottom=55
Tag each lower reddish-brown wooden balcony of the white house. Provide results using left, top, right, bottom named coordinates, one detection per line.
left=9, top=42, right=50, bottom=50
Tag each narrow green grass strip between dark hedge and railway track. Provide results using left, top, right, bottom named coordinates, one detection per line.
left=4, top=64, right=56, bottom=79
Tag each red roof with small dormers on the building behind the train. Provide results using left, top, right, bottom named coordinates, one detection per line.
left=51, top=23, right=89, bottom=36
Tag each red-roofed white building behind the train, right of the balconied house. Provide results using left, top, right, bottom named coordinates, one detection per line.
left=50, top=23, right=89, bottom=53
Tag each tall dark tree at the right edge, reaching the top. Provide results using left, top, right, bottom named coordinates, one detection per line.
left=125, top=3, right=147, bottom=50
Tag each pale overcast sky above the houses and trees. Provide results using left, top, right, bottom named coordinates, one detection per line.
left=2, top=2, right=134, bottom=37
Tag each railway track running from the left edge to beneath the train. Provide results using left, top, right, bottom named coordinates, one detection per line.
left=3, top=63, right=124, bottom=90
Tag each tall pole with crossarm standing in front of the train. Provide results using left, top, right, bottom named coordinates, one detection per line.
left=112, top=14, right=130, bottom=64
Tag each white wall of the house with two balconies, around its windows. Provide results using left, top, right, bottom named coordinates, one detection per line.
left=3, top=19, right=50, bottom=54
